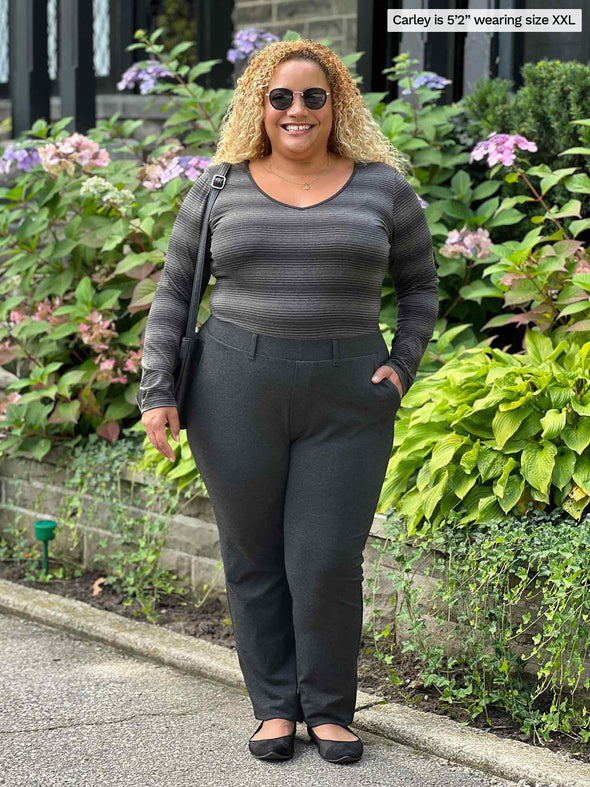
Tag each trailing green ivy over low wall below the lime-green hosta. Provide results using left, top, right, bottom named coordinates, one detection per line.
left=369, top=502, right=590, bottom=752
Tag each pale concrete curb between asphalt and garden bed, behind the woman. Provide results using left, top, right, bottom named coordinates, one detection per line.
left=0, top=579, right=590, bottom=787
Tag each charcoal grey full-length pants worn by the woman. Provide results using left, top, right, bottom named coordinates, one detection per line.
left=187, top=316, right=400, bottom=726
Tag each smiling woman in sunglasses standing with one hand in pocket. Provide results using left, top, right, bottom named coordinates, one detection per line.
left=140, top=40, right=439, bottom=762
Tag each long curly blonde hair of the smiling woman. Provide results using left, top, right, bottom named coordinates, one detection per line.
left=210, top=38, right=411, bottom=175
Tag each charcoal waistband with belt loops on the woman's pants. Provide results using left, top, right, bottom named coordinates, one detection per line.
left=199, top=315, right=387, bottom=364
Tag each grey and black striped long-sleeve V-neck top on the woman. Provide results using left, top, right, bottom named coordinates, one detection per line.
left=138, top=161, right=439, bottom=413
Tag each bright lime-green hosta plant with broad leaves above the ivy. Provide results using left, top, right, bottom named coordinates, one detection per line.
left=379, top=330, right=590, bottom=535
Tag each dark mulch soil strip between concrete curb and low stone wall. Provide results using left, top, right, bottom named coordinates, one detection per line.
left=0, top=560, right=590, bottom=762
